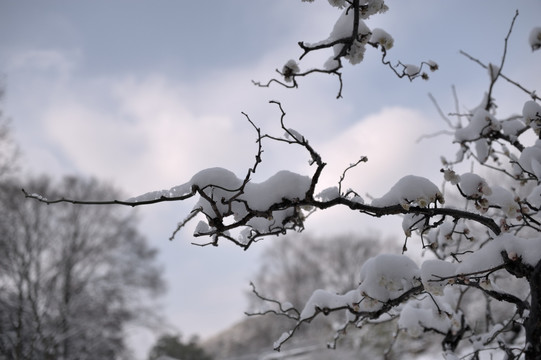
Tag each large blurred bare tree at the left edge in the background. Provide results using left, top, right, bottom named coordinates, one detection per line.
left=0, top=177, right=164, bottom=359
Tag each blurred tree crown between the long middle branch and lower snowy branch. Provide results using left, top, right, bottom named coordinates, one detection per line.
left=251, top=235, right=388, bottom=307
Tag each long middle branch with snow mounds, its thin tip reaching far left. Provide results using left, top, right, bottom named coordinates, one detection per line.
left=23, top=101, right=501, bottom=249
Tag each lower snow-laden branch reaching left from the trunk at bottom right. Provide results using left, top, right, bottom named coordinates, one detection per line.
left=247, top=242, right=541, bottom=350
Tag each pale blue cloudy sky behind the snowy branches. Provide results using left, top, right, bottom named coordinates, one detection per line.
left=0, top=0, right=541, bottom=358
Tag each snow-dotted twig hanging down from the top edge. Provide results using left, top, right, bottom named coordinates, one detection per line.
left=253, top=0, right=438, bottom=98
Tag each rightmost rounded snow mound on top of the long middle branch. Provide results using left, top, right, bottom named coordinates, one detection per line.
left=372, top=175, right=444, bottom=209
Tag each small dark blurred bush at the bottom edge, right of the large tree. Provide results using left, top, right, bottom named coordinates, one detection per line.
left=148, top=334, right=212, bottom=360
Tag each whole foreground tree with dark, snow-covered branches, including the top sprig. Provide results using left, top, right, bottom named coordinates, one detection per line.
left=26, top=0, right=541, bottom=360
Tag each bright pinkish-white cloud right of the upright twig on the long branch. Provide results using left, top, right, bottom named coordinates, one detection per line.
left=321, top=107, right=445, bottom=196
